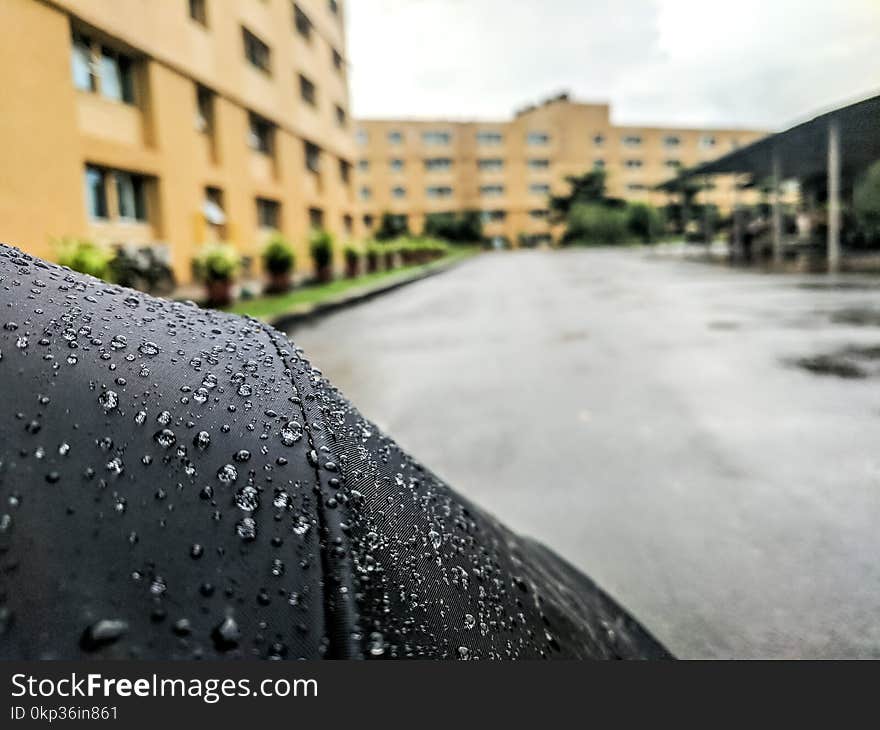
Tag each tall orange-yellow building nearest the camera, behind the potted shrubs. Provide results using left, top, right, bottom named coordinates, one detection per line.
left=0, top=0, right=356, bottom=281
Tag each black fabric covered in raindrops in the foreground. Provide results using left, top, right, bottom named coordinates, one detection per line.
left=0, top=247, right=667, bottom=659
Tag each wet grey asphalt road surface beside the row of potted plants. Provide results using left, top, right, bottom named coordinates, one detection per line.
left=294, top=250, right=880, bottom=657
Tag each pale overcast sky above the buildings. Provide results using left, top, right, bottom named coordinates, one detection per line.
left=348, top=0, right=880, bottom=129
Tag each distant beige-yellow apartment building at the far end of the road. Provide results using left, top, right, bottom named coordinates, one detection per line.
left=355, top=95, right=766, bottom=246
